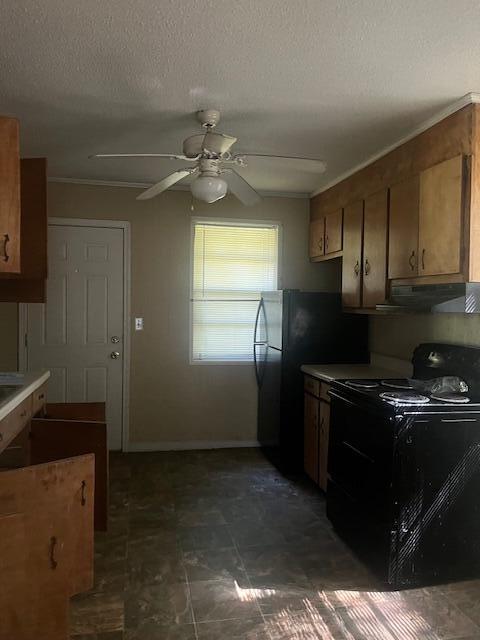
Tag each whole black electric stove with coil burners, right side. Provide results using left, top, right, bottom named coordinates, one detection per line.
left=327, top=343, right=480, bottom=589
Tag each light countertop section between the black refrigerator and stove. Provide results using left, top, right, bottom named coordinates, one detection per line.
left=302, top=354, right=412, bottom=382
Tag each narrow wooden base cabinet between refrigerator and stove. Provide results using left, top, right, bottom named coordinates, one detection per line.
left=303, top=376, right=330, bottom=491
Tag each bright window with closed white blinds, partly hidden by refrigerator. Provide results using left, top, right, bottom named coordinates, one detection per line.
left=191, top=220, right=279, bottom=362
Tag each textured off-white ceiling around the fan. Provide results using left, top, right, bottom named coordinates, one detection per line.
left=0, top=0, right=480, bottom=192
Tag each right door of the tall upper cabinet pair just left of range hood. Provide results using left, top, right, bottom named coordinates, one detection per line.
left=363, top=189, right=388, bottom=308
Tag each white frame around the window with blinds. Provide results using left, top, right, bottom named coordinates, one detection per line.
left=188, top=216, right=283, bottom=367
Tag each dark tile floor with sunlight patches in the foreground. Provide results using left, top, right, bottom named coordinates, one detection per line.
left=71, top=449, right=480, bottom=640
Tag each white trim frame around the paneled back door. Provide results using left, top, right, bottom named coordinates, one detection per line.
left=18, top=217, right=131, bottom=451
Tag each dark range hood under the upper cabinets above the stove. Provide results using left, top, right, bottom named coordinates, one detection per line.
left=376, top=282, right=480, bottom=313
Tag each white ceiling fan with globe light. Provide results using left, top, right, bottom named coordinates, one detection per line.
left=90, top=109, right=326, bottom=205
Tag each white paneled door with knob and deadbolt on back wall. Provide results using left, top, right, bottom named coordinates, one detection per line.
left=26, top=224, right=124, bottom=449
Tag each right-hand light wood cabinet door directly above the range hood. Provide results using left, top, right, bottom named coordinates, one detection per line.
left=418, top=156, right=464, bottom=276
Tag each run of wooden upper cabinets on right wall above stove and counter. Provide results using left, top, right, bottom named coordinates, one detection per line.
left=311, top=104, right=480, bottom=302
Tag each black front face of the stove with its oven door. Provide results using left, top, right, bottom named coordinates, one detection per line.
left=327, top=390, right=395, bottom=579
